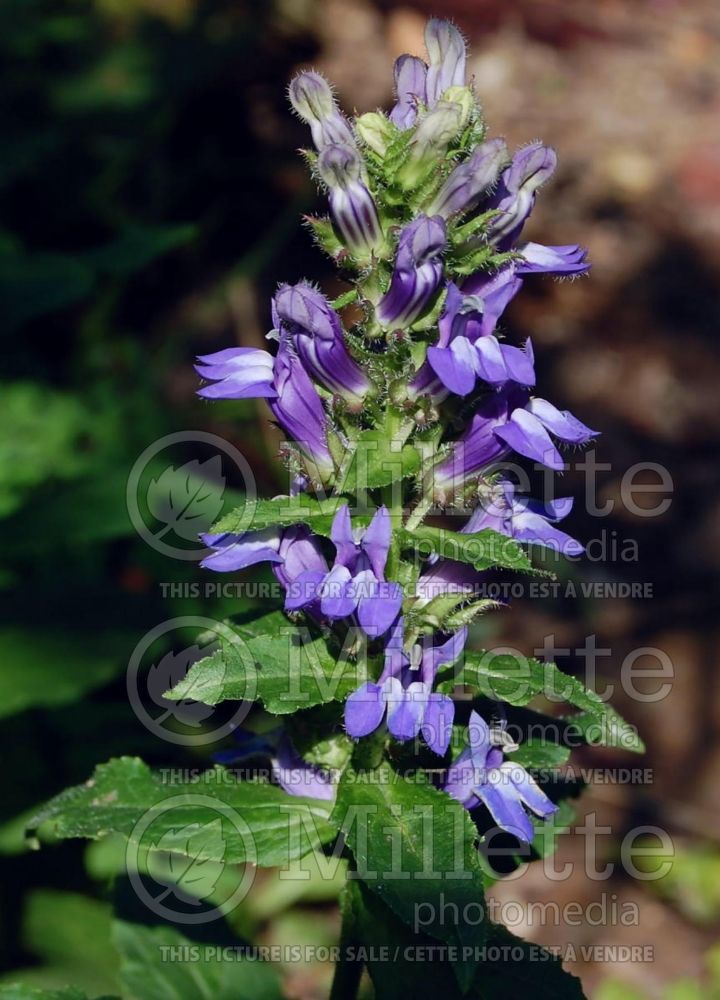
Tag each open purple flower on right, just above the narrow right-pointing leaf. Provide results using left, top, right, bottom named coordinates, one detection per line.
left=462, top=479, right=585, bottom=556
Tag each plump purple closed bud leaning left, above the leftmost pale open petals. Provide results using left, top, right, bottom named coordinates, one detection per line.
left=273, top=281, right=371, bottom=410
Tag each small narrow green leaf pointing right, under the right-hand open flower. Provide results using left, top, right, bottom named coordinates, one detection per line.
left=402, top=525, right=541, bottom=574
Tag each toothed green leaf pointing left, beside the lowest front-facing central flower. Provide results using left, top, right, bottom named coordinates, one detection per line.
left=165, top=611, right=367, bottom=715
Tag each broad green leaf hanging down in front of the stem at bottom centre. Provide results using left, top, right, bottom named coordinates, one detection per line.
left=333, top=764, right=485, bottom=988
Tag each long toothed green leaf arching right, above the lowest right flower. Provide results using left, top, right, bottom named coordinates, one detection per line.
left=438, top=652, right=645, bottom=753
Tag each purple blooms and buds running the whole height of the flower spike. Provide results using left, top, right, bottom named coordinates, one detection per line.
left=197, top=20, right=595, bottom=840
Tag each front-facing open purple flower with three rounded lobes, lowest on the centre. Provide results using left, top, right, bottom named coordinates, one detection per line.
left=345, top=618, right=467, bottom=755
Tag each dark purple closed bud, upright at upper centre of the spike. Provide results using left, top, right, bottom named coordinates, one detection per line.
left=377, top=215, right=446, bottom=328
